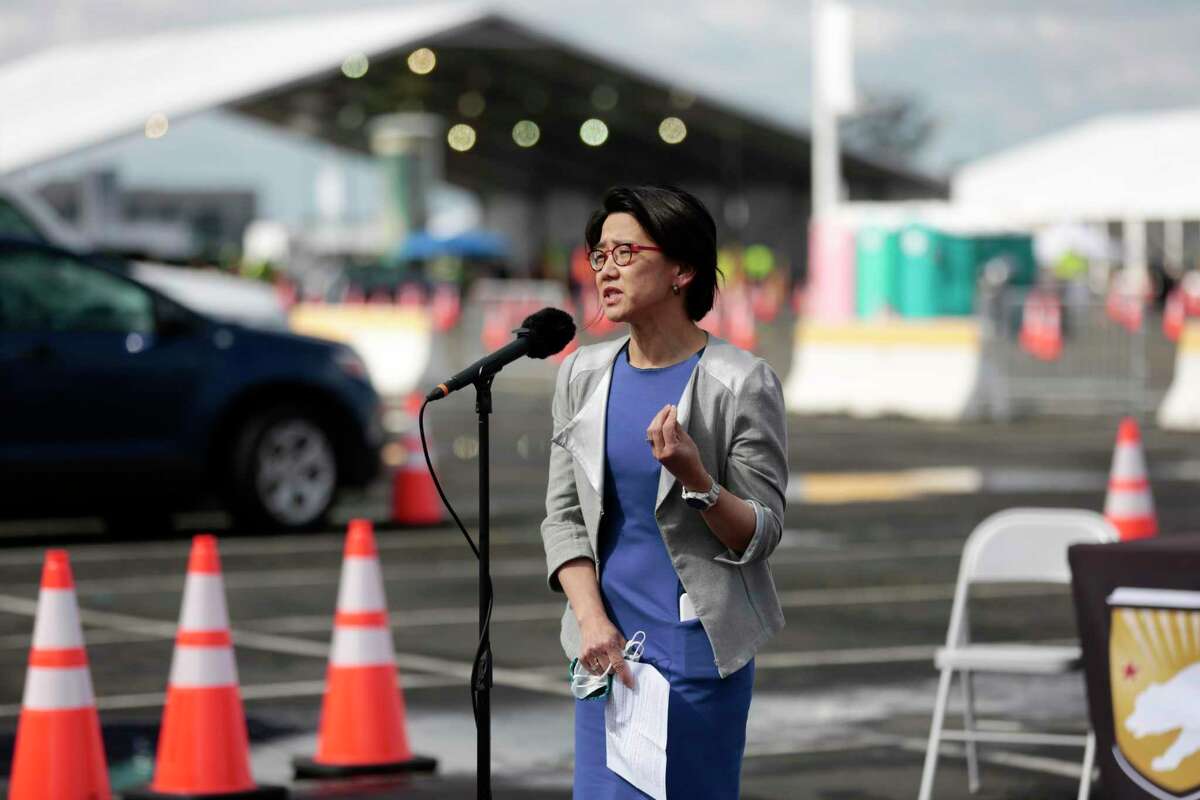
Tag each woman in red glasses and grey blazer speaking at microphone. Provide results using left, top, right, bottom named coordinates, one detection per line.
left=541, top=186, right=787, bottom=800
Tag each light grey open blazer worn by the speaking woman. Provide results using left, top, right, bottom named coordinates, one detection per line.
left=541, top=336, right=787, bottom=678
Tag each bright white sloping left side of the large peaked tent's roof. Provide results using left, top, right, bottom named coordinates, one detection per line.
left=0, top=4, right=487, bottom=174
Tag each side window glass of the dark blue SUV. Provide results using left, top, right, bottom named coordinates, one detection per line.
left=0, top=251, right=154, bottom=333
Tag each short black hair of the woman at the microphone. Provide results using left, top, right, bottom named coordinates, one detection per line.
left=584, top=185, right=720, bottom=321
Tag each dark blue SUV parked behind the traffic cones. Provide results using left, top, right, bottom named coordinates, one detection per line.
left=0, top=239, right=383, bottom=530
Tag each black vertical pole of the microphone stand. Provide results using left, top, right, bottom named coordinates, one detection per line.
left=473, top=373, right=496, bottom=800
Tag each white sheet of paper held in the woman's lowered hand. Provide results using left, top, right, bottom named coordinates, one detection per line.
left=604, top=661, right=671, bottom=800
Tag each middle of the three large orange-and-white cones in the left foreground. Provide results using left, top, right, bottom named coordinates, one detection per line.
left=125, top=534, right=288, bottom=800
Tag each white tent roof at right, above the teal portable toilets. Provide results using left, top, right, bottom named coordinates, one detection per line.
left=952, top=109, right=1200, bottom=225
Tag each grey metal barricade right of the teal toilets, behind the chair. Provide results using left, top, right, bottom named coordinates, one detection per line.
left=979, top=288, right=1174, bottom=417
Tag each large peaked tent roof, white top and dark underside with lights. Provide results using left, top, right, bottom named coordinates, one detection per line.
left=0, top=4, right=944, bottom=198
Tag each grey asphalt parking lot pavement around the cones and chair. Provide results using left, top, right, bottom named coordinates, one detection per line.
left=0, top=395, right=1200, bottom=800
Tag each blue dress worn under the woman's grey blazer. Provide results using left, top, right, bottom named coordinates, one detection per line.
left=574, top=350, right=754, bottom=800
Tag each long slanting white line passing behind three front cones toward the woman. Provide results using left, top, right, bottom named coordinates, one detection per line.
left=0, top=595, right=570, bottom=694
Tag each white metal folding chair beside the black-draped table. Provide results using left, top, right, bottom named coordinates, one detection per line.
left=918, top=509, right=1117, bottom=800
